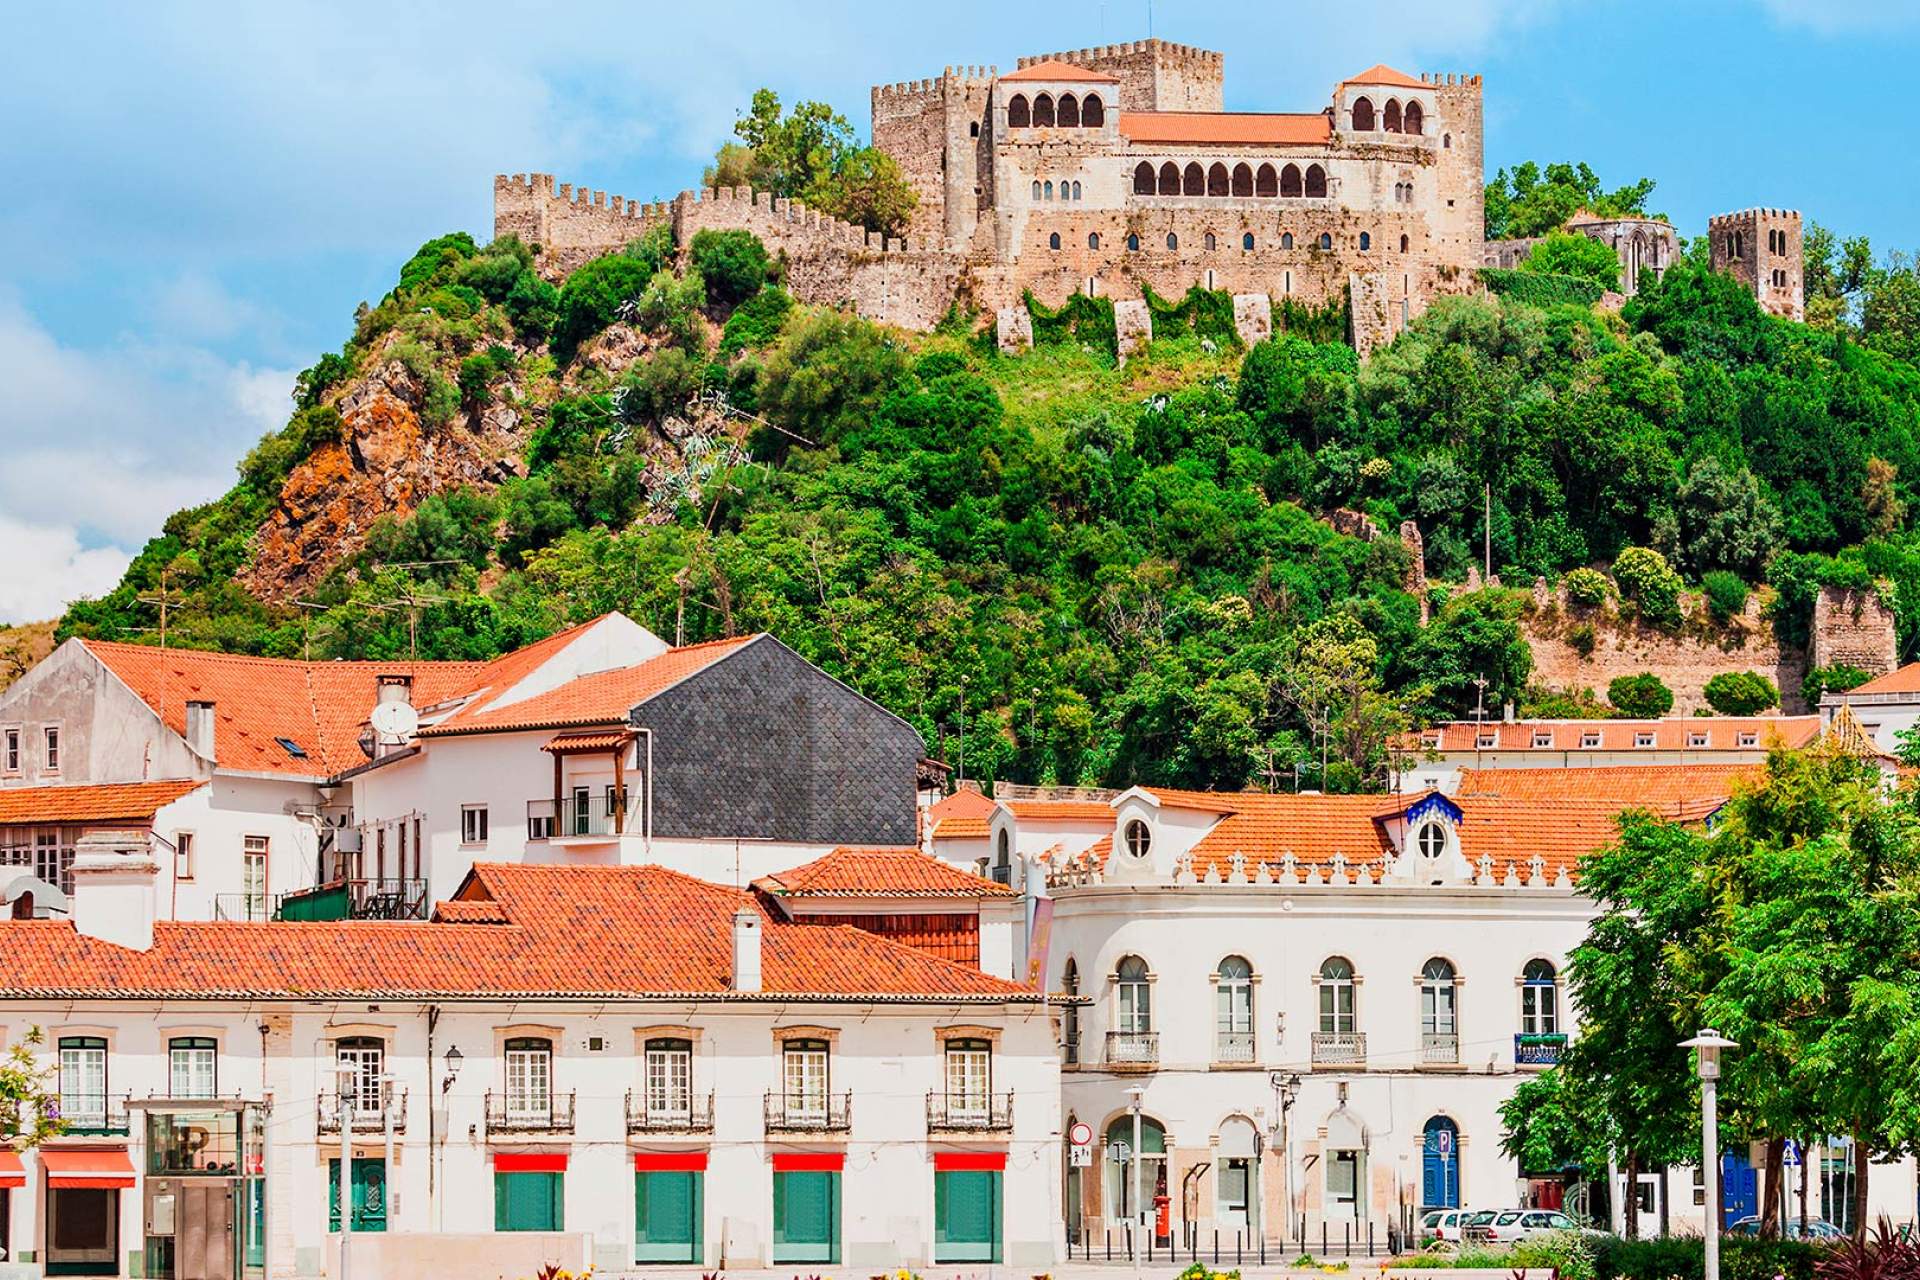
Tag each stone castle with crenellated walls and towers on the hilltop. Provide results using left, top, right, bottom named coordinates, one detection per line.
left=493, top=40, right=1801, bottom=353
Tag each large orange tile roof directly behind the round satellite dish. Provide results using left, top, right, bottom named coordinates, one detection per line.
left=81, top=641, right=484, bottom=777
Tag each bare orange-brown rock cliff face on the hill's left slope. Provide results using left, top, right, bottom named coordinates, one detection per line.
left=240, top=361, right=532, bottom=603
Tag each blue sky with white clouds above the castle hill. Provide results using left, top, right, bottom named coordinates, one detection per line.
left=0, top=0, right=1920, bottom=622
